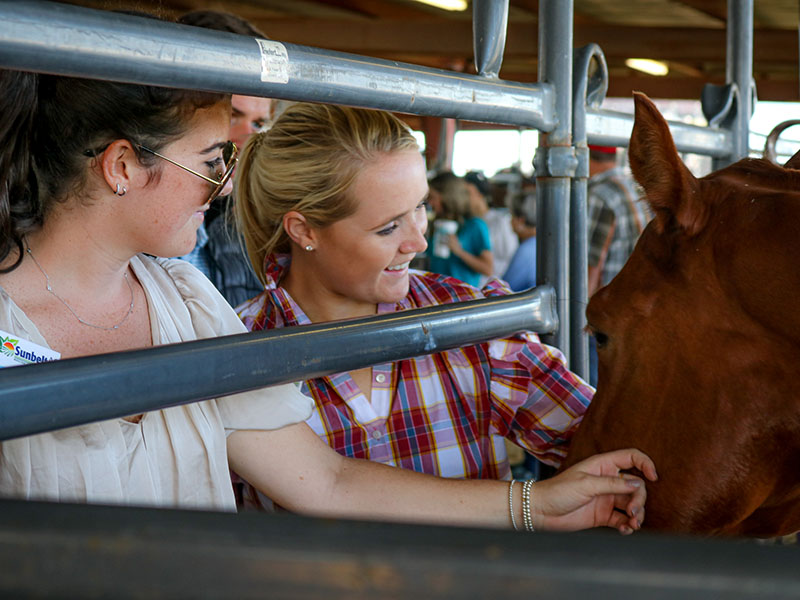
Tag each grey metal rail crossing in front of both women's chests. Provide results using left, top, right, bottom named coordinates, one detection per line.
left=0, top=286, right=558, bottom=440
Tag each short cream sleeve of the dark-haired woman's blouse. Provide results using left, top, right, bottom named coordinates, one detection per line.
left=159, top=260, right=313, bottom=434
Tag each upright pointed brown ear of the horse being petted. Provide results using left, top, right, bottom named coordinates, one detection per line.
left=628, top=92, right=708, bottom=235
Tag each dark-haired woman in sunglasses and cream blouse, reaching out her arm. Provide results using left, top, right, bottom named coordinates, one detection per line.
left=0, top=71, right=655, bottom=532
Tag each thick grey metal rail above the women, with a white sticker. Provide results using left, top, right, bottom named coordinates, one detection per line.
left=0, top=0, right=554, bottom=131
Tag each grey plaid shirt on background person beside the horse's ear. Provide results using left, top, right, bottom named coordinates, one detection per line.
left=586, top=167, right=651, bottom=285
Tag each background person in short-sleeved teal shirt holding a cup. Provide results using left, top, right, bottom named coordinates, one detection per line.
left=429, top=176, right=494, bottom=287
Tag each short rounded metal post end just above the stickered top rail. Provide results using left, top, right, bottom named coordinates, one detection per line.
left=472, top=0, right=508, bottom=78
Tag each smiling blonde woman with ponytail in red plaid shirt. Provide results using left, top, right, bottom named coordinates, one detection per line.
left=235, top=104, right=656, bottom=528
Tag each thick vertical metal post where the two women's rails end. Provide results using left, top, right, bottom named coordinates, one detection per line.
left=534, top=0, right=577, bottom=360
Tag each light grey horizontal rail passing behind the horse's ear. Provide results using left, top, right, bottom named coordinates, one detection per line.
left=586, top=108, right=733, bottom=157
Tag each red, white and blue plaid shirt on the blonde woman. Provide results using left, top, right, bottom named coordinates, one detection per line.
left=238, top=256, right=593, bottom=479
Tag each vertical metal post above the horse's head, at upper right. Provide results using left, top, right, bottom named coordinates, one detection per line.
left=725, top=0, right=755, bottom=162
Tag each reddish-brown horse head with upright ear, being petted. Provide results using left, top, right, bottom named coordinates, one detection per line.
left=568, top=94, right=800, bottom=536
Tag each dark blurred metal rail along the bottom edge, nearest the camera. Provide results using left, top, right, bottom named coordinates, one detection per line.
left=0, top=501, right=800, bottom=600
